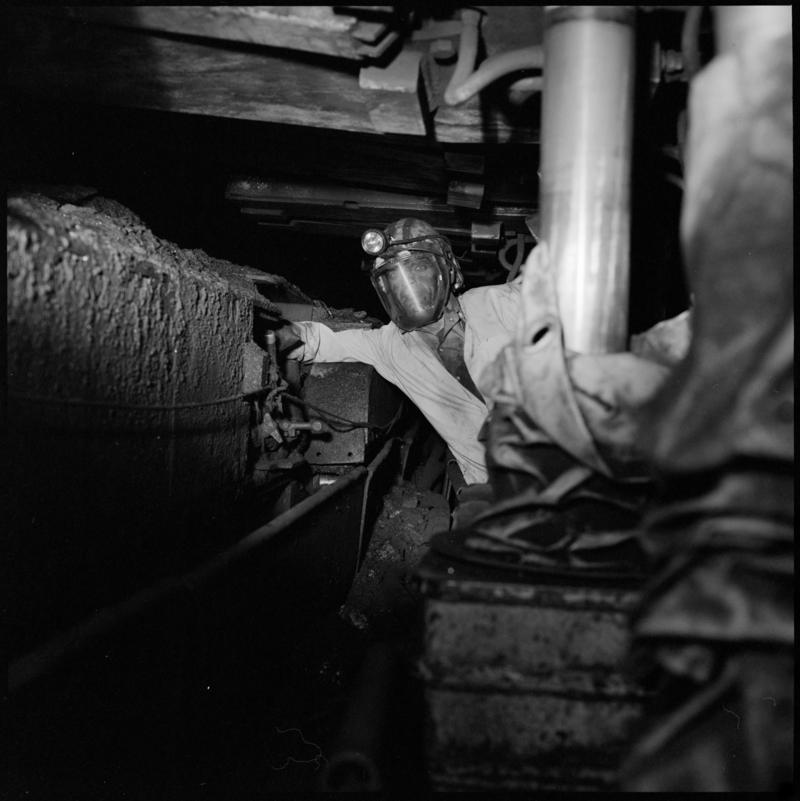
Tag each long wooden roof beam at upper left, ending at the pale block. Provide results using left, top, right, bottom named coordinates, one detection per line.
left=8, top=11, right=376, bottom=133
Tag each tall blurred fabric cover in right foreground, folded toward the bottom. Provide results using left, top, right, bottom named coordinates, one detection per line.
left=622, top=18, right=794, bottom=792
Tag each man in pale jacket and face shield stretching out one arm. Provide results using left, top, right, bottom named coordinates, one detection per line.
left=279, top=217, right=520, bottom=484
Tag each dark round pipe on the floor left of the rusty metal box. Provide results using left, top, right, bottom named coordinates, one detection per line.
left=320, top=642, right=399, bottom=792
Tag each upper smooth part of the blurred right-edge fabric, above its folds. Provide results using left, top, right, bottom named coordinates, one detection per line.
left=643, top=31, right=794, bottom=472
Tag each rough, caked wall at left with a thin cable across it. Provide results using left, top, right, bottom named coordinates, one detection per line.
left=7, top=193, right=288, bottom=647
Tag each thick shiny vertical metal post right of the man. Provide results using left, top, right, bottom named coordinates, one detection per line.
left=540, top=6, right=635, bottom=353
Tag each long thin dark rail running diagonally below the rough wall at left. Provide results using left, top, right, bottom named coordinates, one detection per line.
left=8, top=467, right=367, bottom=694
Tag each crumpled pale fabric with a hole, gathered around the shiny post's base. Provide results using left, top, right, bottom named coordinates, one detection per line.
left=438, top=243, right=670, bottom=570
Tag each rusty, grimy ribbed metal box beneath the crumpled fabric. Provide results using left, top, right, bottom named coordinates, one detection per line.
left=418, top=557, right=643, bottom=790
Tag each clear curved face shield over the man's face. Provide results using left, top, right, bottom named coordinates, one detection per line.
left=370, top=247, right=451, bottom=331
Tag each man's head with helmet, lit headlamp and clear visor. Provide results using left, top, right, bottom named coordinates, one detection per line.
left=361, top=217, right=464, bottom=331
